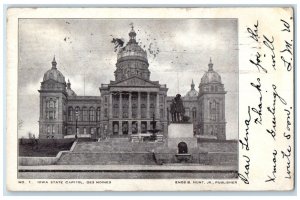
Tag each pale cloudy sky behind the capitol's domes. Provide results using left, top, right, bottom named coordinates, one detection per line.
left=18, top=19, right=238, bottom=139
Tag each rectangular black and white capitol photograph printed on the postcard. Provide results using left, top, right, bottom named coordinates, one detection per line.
left=18, top=18, right=238, bottom=179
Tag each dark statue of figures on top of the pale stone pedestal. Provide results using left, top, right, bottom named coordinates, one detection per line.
left=170, top=94, right=185, bottom=122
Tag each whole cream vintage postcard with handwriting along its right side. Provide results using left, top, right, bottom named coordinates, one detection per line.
left=6, top=6, right=295, bottom=191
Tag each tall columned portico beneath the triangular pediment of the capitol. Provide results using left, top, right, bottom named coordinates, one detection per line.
left=104, top=87, right=166, bottom=135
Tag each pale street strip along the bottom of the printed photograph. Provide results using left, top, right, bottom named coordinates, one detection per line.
left=18, top=165, right=237, bottom=179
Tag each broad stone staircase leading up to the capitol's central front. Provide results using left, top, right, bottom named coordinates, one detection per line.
left=56, top=138, right=164, bottom=165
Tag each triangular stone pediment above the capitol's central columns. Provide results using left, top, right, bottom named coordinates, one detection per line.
left=111, top=77, right=159, bottom=87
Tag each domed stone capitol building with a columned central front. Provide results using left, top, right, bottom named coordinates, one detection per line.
left=39, top=27, right=226, bottom=140
